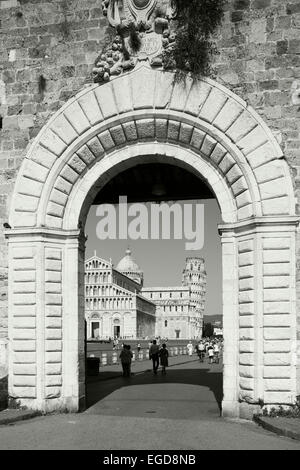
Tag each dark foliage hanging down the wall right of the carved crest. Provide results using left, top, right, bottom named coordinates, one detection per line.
left=165, top=0, right=225, bottom=77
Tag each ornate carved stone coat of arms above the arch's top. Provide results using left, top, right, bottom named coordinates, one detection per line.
left=93, top=0, right=175, bottom=83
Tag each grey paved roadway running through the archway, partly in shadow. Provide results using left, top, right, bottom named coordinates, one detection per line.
left=0, top=360, right=300, bottom=450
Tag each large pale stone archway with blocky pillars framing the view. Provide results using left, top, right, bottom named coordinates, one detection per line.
left=6, top=65, right=298, bottom=416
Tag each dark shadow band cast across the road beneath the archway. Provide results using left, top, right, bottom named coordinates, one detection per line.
left=87, top=368, right=223, bottom=411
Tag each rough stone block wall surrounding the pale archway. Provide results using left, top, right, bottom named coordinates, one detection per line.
left=0, top=0, right=300, bottom=404
